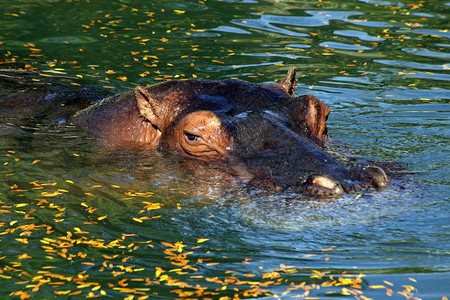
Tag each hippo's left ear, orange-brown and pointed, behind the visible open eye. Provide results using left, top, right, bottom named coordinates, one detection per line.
left=134, top=86, right=163, bottom=131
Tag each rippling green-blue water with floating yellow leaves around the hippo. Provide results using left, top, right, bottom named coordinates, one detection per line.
left=0, top=0, right=450, bottom=299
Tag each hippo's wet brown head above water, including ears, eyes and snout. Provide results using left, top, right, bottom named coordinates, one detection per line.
left=71, top=68, right=387, bottom=198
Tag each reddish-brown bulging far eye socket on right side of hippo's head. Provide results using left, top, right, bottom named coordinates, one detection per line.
left=288, top=95, right=331, bottom=141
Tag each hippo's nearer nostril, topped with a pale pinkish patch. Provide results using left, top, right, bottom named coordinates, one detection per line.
left=303, top=175, right=344, bottom=199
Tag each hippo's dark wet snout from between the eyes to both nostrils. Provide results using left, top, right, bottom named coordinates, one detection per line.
left=225, top=110, right=387, bottom=198
